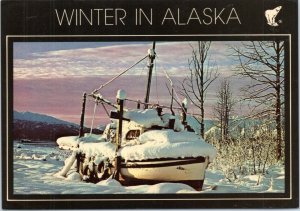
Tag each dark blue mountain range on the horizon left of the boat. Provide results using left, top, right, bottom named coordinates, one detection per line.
left=13, top=111, right=102, bottom=141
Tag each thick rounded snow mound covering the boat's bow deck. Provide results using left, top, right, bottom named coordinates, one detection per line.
left=121, top=130, right=216, bottom=161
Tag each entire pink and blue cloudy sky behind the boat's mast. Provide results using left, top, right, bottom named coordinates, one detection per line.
left=13, top=42, right=247, bottom=126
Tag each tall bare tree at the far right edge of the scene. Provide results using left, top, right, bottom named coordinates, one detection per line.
left=232, top=40, right=285, bottom=160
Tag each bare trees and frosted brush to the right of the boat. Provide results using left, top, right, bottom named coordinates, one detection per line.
left=181, top=39, right=287, bottom=180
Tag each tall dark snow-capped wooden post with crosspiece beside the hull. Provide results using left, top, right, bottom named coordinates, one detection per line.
left=113, top=90, right=126, bottom=180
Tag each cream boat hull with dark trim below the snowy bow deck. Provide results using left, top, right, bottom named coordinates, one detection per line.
left=120, top=157, right=208, bottom=190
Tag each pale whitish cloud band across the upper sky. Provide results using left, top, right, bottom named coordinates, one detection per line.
left=14, top=42, right=239, bottom=79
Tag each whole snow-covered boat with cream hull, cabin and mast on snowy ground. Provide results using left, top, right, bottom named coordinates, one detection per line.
left=57, top=42, right=216, bottom=190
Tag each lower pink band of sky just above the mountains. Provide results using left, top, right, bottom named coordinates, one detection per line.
left=14, top=76, right=185, bottom=124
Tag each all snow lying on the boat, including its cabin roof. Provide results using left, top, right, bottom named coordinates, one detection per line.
left=57, top=109, right=216, bottom=162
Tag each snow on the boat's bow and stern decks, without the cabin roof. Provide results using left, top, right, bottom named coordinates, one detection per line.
left=56, top=130, right=216, bottom=161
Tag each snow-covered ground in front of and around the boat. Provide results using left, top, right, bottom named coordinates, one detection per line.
left=13, top=142, right=285, bottom=194
